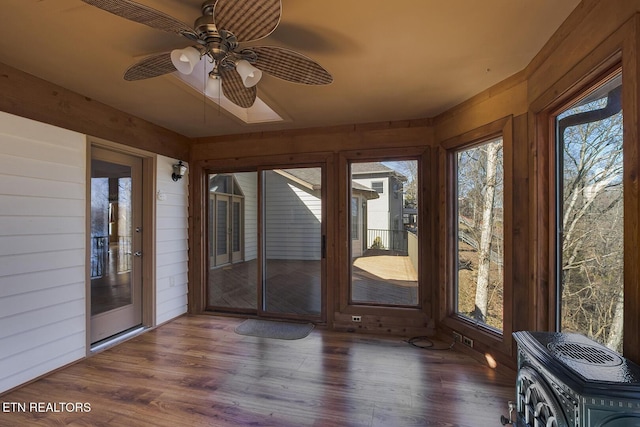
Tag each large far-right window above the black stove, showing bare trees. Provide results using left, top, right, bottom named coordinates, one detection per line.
left=554, top=73, right=624, bottom=352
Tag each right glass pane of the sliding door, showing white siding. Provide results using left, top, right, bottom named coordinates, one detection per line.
left=263, top=168, right=322, bottom=315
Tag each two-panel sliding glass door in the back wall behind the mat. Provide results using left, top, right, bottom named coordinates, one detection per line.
left=207, top=167, right=324, bottom=318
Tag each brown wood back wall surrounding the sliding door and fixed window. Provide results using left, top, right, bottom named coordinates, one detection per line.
left=189, top=124, right=436, bottom=334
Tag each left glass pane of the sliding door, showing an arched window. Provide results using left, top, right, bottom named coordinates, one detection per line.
left=207, top=172, right=258, bottom=311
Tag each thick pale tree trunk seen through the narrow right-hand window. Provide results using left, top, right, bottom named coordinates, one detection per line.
left=475, top=142, right=500, bottom=322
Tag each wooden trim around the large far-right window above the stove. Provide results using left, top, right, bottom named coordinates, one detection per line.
left=529, top=25, right=640, bottom=363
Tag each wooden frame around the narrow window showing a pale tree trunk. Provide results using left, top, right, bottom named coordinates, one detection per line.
left=438, top=116, right=514, bottom=356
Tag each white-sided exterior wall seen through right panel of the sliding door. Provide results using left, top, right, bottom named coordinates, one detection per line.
left=265, top=172, right=322, bottom=260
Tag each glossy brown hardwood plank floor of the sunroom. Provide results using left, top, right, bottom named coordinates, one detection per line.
left=0, top=316, right=515, bottom=427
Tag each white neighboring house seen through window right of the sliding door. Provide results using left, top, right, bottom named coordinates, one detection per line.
left=351, top=162, right=407, bottom=251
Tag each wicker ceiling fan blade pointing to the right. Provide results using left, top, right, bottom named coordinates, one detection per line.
left=251, top=46, right=333, bottom=85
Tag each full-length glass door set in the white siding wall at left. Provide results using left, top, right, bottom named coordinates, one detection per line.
left=90, top=147, right=142, bottom=343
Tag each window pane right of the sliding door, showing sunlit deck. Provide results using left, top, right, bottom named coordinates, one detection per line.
left=349, top=160, right=419, bottom=306
